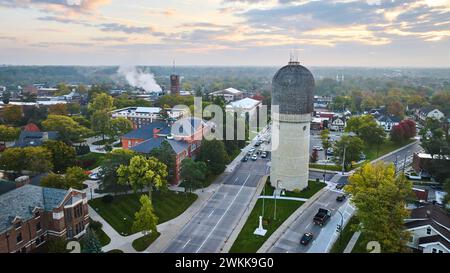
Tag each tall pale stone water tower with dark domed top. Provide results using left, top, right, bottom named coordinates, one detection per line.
left=270, top=61, right=315, bottom=191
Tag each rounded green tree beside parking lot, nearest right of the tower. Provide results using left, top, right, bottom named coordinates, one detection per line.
left=333, top=135, right=364, bottom=170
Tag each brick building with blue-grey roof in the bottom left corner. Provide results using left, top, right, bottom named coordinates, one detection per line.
left=0, top=185, right=89, bottom=253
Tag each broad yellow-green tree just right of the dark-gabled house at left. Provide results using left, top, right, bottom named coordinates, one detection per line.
left=42, top=115, right=90, bottom=143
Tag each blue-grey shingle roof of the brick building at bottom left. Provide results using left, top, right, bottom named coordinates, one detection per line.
left=0, top=185, right=67, bottom=232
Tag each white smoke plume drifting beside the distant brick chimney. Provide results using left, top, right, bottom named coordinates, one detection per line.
left=117, top=66, right=162, bottom=92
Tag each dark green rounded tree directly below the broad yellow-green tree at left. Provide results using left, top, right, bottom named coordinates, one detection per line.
left=42, top=140, right=77, bottom=173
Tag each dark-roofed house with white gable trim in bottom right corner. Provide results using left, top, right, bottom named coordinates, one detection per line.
left=405, top=204, right=450, bottom=253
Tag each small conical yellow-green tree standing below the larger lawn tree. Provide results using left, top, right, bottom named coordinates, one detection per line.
left=132, top=194, right=158, bottom=234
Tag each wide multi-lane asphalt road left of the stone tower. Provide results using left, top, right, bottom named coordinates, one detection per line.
left=164, top=154, right=269, bottom=253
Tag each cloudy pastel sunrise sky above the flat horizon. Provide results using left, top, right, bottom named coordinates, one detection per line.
left=0, top=0, right=450, bottom=67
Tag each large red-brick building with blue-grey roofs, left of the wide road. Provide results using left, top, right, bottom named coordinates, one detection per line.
left=121, top=117, right=209, bottom=184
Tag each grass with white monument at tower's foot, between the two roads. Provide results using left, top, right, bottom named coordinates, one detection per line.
left=230, top=181, right=326, bottom=253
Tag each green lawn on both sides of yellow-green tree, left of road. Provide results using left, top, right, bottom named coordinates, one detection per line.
left=89, top=191, right=197, bottom=235
